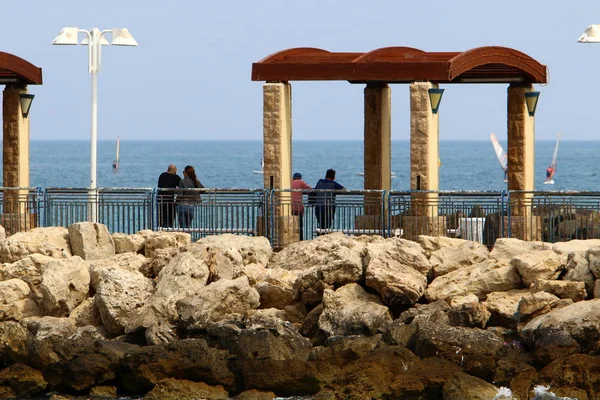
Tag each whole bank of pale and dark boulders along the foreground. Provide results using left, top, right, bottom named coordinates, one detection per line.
left=0, top=223, right=600, bottom=400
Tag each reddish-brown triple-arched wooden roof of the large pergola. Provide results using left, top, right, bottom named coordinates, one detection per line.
left=252, top=46, right=548, bottom=83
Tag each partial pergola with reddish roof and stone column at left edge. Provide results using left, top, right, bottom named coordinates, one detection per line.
left=0, top=52, right=42, bottom=233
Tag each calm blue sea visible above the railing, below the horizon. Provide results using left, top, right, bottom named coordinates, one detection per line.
left=0, top=139, right=600, bottom=190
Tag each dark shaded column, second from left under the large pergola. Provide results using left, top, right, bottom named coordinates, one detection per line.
left=357, top=83, right=392, bottom=229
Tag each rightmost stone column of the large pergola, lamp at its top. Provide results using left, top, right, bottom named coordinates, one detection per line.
left=506, top=84, right=541, bottom=240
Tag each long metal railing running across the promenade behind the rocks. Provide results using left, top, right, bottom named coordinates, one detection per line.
left=0, top=188, right=600, bottom=248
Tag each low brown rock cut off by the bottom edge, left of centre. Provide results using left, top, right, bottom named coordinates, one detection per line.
left=144, top=378, right=229, bottom=400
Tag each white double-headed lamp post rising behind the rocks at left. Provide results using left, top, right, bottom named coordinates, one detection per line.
left=52, top=27, right=137, bottom=222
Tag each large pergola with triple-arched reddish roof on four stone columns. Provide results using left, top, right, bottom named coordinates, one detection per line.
left=252, top=46, right=548, bottom=242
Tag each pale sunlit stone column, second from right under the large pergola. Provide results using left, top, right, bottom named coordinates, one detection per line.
left=404, top=82, right=446, bottom=238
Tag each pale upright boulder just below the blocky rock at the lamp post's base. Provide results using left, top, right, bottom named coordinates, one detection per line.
left=40, top=256, right=90, bottom=317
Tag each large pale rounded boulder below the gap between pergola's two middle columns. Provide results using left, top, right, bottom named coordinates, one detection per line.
left=365, top=238, right=431, bottom=306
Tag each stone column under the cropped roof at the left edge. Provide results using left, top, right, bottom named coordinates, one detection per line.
left=1, top=85, right=35, bottom=234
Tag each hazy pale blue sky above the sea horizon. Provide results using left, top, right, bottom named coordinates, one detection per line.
left=0, top=0, right=600, bottom=140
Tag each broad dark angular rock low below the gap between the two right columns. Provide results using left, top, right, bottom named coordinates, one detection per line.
left=414, top=321, right=504, bottom=380
